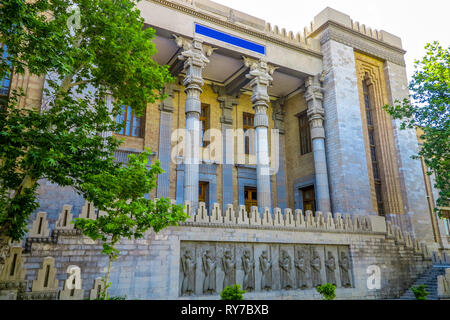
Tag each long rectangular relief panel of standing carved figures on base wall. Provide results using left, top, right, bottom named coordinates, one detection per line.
left=179, top=241, right=352, bottom=296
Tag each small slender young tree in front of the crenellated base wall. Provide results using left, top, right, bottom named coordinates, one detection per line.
left=75, top=150, right=188, bottom=299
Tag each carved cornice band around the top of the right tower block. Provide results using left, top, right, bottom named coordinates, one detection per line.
left=308, top=21, right=406, bottom=66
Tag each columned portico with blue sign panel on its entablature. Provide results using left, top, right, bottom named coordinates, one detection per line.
left=141, top=1, right=330, bottom=212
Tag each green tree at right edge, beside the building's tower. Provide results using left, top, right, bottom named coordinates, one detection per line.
left=384, top=42, right=450, bottom=218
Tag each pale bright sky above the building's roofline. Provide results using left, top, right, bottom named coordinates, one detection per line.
left=213, top=0, right=450, bottom=78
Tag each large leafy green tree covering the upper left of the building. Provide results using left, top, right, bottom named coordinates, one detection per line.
left=0, top=0, right=173, bottom=240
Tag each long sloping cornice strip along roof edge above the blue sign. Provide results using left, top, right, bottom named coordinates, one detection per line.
left=146, top=0, right=323, bottom=59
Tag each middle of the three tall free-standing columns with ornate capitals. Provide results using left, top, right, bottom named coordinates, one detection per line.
left=244, top=58, right=275, bottom=210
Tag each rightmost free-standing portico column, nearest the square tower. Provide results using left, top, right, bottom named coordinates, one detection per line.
left=305, top=75, right=331, bottom=212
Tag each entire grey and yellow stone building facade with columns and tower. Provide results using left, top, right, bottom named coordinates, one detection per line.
left=0, top=0, right=450, bottom=299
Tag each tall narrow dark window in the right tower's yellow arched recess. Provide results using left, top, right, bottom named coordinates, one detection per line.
left=362, top=80, right=385, bottom=216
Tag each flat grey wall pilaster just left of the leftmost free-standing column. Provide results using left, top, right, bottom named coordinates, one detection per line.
left=156, top=83, right=179, bottom=198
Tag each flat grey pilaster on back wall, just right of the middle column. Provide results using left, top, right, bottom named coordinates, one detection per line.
left=272, top=97, right=287, bottom=210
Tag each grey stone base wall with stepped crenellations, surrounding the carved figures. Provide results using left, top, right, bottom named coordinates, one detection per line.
left=0, top=204, right=431, bottom=299
